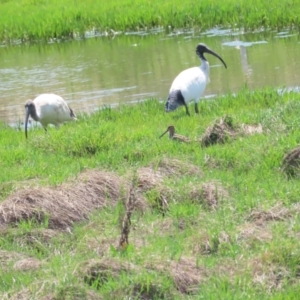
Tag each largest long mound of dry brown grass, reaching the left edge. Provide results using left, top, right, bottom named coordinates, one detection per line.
left=0, top=171, right=126, bottom=229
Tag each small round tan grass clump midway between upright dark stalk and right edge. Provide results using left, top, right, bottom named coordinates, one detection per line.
left=189, top=181, right=229, bottom=210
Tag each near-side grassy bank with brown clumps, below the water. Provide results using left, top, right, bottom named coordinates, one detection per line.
left=0, top=89, right=300, bottom=299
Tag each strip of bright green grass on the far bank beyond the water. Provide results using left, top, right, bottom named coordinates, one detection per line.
left=0, top=0, right=300, bottom=43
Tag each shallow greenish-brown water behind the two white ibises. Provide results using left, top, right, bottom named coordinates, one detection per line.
left=0, top=29, right=300, bottom=124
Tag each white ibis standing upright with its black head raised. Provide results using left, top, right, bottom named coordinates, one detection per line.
left=165, top=43, right=227, bottom=115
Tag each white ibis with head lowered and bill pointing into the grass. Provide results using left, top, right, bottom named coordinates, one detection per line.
left=25, top=94, right=76, bottom=138
